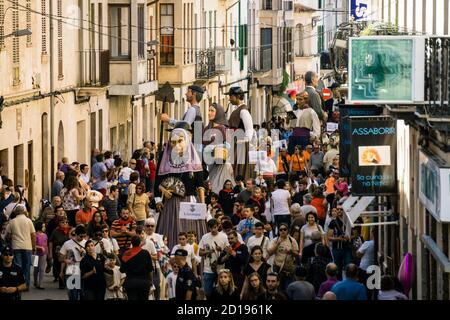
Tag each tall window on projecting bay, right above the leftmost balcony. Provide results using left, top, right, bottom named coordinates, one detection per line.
left=109, top=5, right=131, bottom=60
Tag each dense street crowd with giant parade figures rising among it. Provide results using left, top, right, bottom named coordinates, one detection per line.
left=0, top=72, right=406, bottom=301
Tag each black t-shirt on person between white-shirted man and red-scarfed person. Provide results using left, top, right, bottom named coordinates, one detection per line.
left=80, top=254, right=106, bottom=290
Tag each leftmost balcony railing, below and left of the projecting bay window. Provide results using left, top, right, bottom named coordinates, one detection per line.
left=80, top=49, right=109, bottom=87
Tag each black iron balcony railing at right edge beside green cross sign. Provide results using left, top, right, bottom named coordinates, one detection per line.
left=419, top=37, right=450, bottom=118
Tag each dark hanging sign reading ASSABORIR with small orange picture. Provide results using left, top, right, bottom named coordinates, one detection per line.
left=350, top=116, right=397, bottom=195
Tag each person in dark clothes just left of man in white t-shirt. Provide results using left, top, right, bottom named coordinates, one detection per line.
left=48, top=216, right=71, bottom=289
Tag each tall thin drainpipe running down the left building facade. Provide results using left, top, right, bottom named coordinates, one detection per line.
left=46, top=1, right=55, bottom=183
